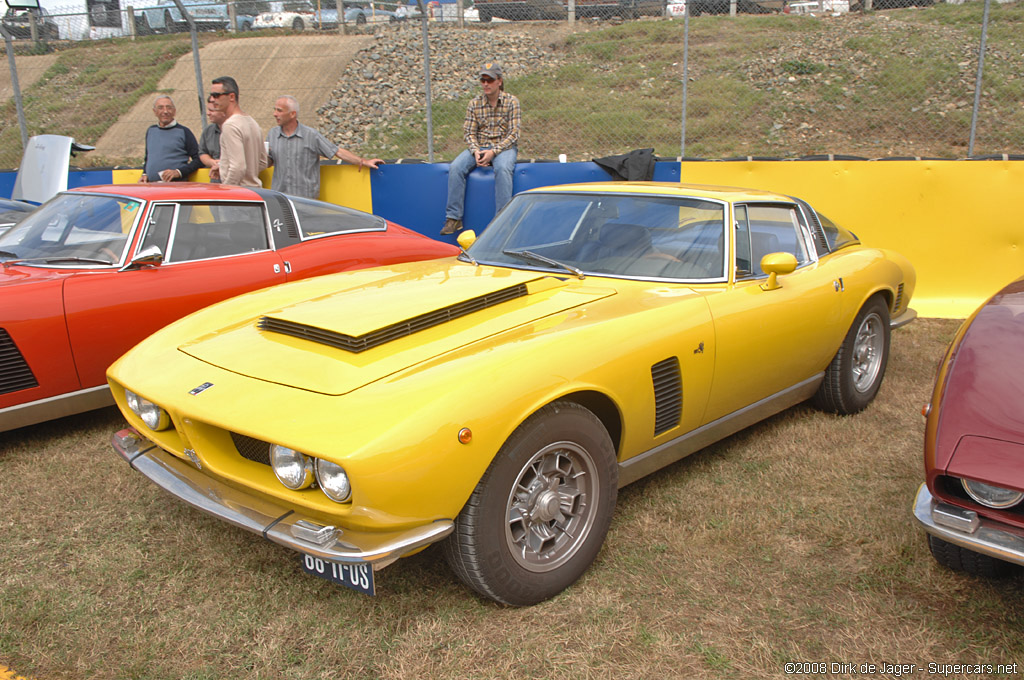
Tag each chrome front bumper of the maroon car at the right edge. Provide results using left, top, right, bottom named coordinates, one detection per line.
left=913, top=484, right=1024, bottom=564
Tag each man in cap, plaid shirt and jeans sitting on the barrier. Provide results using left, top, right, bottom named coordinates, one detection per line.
left=441, top=61, right=521, bottom=236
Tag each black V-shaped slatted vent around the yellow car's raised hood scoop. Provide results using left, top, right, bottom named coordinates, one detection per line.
left=256, top=284, right=528, bottom=354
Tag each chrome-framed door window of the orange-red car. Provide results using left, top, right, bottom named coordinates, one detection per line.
left=166, top=203, right=269, bottom=262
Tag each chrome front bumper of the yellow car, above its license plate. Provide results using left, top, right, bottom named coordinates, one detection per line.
left=113, top=428, right=455, bottom=569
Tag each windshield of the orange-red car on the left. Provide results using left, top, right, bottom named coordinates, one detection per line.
left=0, top=194, right=142, bottom=265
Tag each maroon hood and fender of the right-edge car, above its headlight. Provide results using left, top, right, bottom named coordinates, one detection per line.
left=936, top=278, right=1024, bottom=471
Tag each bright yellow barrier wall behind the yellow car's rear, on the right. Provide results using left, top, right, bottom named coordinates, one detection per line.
left=680, top=161, right=1024, bottom=318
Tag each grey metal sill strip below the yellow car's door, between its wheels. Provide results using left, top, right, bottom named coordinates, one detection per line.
left=618, top=373, right=824, bottom=488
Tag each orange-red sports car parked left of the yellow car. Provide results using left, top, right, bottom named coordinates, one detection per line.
left=0, top=183, right=459, bottom=431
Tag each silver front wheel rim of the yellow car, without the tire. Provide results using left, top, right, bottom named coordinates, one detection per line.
left=505, top=441, right=600, bottom=572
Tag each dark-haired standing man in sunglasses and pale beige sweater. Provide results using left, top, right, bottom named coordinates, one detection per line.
left=207, top=76, right=266, bottom=186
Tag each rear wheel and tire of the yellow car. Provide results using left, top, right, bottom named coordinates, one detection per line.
left=814, top=295, right=890, bottom=416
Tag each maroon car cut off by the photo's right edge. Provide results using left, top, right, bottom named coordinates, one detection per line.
left=913, top=277, right=1024, bottom=577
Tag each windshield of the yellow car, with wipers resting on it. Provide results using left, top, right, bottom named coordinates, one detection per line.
left=470, top=193, right=725, bottom=280
